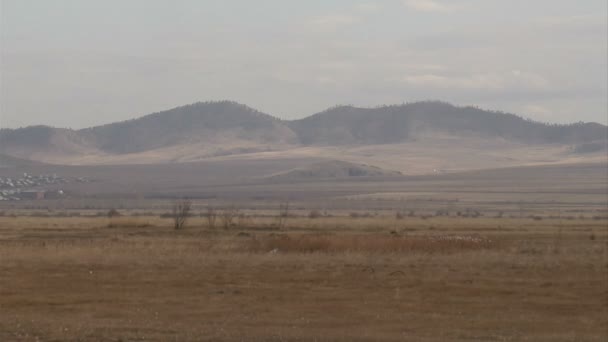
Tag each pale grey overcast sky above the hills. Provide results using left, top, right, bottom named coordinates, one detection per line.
left=0, top=0, right=608, bottom=128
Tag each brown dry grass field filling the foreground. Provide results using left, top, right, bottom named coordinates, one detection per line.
left=0, top=214, right=608, bottom=341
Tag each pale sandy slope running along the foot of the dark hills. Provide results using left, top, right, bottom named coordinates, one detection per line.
left=23, top=136, right=607, bottom=174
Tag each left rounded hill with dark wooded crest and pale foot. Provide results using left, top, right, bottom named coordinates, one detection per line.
left=0, top=101, right=299, bottom=160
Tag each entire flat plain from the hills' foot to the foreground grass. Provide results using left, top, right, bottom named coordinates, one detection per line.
left=0, top=150, right=608, bottom=341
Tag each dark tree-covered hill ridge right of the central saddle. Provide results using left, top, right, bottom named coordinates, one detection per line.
left=289, top=102, right=608, bottom=145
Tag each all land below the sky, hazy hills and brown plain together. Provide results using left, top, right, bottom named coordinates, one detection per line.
left=0, top=103, right=608, bottom=341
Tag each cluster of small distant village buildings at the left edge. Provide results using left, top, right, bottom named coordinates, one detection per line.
left=0, top=173, right=70, bottom=201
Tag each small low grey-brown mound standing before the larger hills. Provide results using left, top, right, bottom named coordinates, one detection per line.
left=266, top=160, right=402, bottom=181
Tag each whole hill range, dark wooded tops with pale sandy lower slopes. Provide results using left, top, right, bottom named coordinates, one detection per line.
left=0, top=101, right=608, bottom=174
